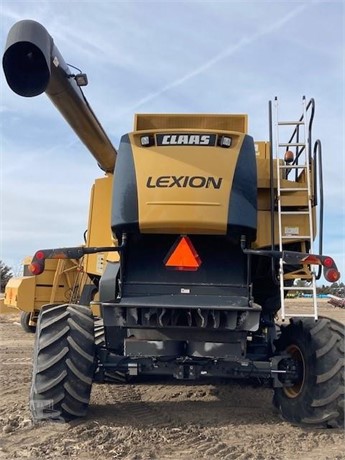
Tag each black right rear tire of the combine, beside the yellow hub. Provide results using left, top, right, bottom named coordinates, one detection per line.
left=273, top=317, right=345, bottom=428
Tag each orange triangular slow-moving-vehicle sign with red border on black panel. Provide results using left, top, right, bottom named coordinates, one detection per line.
left=164, top=236, right=201, bottom=271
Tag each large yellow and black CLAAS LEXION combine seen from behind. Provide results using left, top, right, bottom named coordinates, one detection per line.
left=3, top=21, right=344, bottom=427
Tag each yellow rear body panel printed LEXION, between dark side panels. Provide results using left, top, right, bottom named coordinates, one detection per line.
left=130, top=130, right=244, bottom=234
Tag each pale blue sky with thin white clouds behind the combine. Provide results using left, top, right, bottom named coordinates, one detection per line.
left=0, top=0, right=345, bottom=282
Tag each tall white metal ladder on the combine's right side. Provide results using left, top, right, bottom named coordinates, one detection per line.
left=274, top=97, right=318, bottom=321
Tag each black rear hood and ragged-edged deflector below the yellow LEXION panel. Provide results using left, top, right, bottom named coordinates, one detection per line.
left=102, top=234, right=261, bottom=349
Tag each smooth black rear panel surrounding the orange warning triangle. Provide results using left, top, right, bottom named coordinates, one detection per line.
left=122, top=234, right=248, bottom=297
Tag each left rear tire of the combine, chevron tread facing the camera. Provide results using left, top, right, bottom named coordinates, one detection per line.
left=30, top=305, right=95, bottom=421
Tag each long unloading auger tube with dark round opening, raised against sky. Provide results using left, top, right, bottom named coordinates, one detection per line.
left=3, top=20, right=117, bottom=173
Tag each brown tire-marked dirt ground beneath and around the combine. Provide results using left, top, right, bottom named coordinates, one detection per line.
left=0, top=301, right=345, bottom=460
